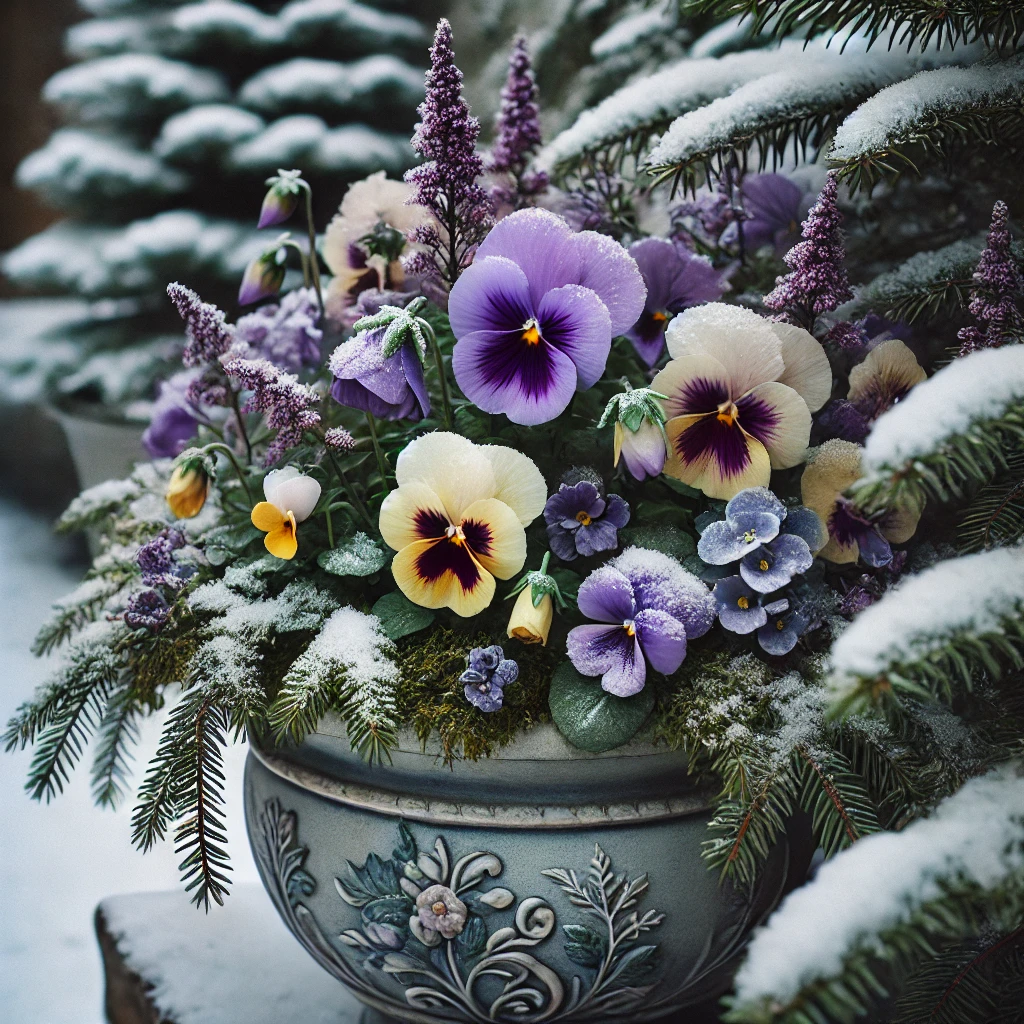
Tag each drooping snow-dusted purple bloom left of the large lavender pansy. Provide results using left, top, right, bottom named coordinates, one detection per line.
left=330, top=328, right=430, bottom=421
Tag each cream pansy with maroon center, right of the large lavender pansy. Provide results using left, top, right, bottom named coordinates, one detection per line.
left=650, top=302, right=831, bottom=500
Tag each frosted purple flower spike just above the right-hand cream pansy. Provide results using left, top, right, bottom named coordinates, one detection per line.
left=764, top=172, right=853, bottom=328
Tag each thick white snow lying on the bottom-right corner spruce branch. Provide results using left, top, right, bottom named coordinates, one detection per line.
left=729, top=766, right=1024, bottom=1022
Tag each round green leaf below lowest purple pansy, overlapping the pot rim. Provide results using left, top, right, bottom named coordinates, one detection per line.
left=548, top=662, right=654, bottom=754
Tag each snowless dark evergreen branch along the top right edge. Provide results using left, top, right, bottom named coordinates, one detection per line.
left=685, top=0, right=1024, bottom=49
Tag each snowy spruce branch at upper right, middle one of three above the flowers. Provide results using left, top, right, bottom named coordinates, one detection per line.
left=647, top=39, right=978, bottom=189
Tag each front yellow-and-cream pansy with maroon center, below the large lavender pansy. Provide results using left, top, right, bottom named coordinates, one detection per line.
left=380, top=431, right=548, bottom=616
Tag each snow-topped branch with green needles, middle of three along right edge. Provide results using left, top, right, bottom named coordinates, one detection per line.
left=828, top=548, right=1024, bottom=710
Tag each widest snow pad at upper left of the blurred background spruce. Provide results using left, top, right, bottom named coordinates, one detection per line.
left=43, top=53, right=228, bottom=121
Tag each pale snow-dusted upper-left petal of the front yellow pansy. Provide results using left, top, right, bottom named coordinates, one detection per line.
left=395, top=430, right=498, bottom=522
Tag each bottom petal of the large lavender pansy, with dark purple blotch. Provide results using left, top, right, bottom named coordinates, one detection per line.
left=452, top=331, right=577, bottom=426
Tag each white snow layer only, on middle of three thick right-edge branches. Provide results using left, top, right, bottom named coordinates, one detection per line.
left=829, top=548, right=1024, bottom=693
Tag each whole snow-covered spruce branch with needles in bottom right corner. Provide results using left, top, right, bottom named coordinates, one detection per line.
left=726, top=765, right=1024, bottom=1024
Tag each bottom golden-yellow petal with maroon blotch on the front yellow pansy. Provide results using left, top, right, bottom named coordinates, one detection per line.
left=391, top=538, right=495, bottom=616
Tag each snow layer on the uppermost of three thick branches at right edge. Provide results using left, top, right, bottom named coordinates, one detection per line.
left=863, top=345, right=1024, bottom=473
